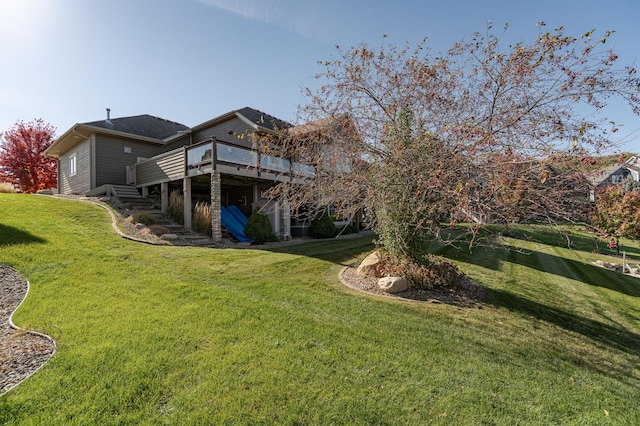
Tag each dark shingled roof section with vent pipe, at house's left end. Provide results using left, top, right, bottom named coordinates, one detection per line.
left=82, top=114, right=189, bottom=139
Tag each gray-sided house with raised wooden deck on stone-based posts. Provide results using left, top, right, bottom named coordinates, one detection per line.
left=45, top=107, right=315, bottom=240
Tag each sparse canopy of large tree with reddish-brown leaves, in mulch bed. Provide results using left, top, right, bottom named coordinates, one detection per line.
left=262, top=26, right=640, bottom=258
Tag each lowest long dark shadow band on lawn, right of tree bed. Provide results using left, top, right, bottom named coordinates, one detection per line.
left=485, top=288, right=640, bottom=355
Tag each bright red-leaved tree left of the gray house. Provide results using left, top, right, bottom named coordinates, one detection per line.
left=0, top=119, right=57, bottom=192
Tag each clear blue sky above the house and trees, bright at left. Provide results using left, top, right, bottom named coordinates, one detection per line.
left=0, top=0, right=640, bottom=152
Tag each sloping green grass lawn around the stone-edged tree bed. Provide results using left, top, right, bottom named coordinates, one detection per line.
left=0, top=194, right=640, bottom=425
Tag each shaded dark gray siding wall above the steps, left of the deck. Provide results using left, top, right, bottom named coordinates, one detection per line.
left=95, top=135, right=162, bottom=187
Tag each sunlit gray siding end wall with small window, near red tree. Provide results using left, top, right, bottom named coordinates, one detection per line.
left=58, top=138, right=91, bottom=194
